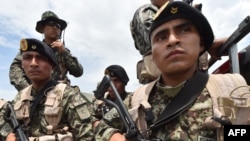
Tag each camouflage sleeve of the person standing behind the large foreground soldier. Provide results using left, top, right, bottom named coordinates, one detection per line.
left=130, top=4, right=158, bottom=55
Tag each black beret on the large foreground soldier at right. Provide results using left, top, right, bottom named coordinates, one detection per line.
left=149, top=1, right=214, bottom=54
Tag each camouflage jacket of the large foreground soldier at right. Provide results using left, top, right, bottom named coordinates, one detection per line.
left=94, top=79, right=216, bottom=141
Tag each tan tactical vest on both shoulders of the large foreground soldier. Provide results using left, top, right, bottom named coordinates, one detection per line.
left=129, top=74, right=250, bottom=141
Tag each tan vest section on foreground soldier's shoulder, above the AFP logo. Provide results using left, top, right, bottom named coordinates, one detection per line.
left=205, top=74, right=250, bottom=141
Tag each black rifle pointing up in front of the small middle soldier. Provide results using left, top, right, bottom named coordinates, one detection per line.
left=94, top=75, right=161, bottom=141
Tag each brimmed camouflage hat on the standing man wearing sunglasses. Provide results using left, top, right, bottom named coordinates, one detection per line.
left=36, top=11, right=67, bottom=33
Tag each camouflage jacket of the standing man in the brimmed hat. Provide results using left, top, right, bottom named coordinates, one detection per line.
left=9, top=48, right=83, bottom=91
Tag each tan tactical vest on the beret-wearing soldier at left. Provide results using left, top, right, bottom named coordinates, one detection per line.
left=14, top=83, right=73, bottom=141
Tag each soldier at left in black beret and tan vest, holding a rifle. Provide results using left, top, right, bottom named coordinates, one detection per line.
left=0, top=38, right=95, bottom=141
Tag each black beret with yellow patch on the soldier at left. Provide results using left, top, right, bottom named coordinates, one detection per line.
left=20, top=38, right=57, bottom=66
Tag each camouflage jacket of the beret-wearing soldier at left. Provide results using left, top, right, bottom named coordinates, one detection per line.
left=0, top=83, right=95, bottom=141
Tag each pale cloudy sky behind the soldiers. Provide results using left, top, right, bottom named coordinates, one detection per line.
left=0, top=0, right=250, bottom=100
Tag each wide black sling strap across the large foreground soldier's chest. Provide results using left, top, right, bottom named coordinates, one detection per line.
left=150, top=71, right=208, bottom=129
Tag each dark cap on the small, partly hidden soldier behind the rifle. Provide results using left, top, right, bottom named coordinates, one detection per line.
left=104, top=65, right=129, bottom=85
